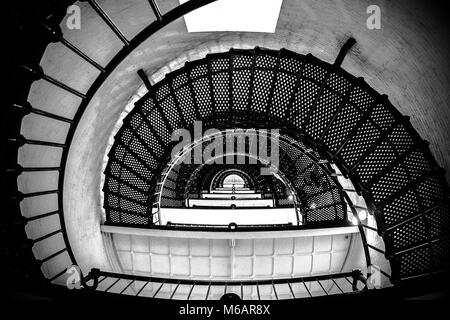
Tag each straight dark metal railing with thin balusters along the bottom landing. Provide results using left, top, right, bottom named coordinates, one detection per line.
left=82, top=269, right=367, bottom=300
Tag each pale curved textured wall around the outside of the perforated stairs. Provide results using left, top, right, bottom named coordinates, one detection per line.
left=19, top=0, right=450, bottom=276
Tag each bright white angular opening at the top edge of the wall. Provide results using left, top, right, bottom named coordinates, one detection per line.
left=180, top=0, right=283, bottom=33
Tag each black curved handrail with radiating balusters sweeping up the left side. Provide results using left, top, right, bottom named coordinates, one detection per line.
left=13, top=0, right=216, bottom=281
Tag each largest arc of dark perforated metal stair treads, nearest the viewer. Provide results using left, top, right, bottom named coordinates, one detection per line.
left=104, top=48, right=449, bottom=279
